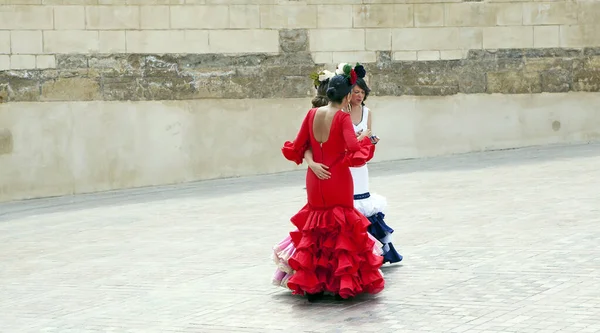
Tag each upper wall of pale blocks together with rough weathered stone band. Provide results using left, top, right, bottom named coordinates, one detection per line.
left=0, top=0, right=600, bottom=101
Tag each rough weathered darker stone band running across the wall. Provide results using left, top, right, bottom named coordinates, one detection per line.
left=0, top=45, right=600, bottom=102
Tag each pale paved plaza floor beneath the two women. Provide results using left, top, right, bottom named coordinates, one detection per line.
left=0, top=144, right=600, bottom=333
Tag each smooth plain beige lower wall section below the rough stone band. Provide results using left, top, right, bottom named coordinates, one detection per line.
left=0, top=92, right=600, bottom=201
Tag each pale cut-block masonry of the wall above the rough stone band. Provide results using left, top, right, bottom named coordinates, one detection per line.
left=0, top=0, right=600, bottom=69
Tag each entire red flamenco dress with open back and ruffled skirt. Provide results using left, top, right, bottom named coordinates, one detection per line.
left=282, top=109, right=384, bottom=298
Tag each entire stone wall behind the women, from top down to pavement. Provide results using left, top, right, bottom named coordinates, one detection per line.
left=0, top=0, right=600, bottom=201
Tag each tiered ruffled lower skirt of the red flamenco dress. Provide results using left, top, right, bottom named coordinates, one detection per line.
left=287, top=204, right=385, bottom=298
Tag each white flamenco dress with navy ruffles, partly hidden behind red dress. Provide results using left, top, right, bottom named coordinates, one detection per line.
left=350, top=106, right=402, bottom=263
